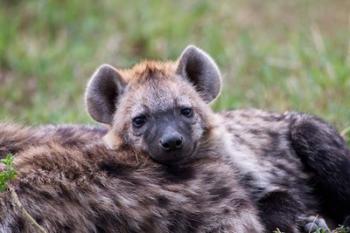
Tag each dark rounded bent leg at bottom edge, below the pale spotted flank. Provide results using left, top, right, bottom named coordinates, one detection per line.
left=258, top=191, right=304, bottom=233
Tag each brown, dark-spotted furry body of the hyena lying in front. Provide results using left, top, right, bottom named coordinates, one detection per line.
left=0, top=125, right=264, bottom=233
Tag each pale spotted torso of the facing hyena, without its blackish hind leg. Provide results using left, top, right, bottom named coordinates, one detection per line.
left=221, top=109, right=322, bottom=232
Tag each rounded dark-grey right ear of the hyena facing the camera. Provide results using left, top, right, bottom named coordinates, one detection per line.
left=176, top=45, right=221, bottom=103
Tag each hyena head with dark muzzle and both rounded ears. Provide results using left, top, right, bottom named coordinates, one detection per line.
left=86, top=46, right=221, bottom=164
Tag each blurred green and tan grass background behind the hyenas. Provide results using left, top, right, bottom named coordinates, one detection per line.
left=0, top=0, right=350, bottom=141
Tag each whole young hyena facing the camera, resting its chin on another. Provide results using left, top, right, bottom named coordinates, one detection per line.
left=86, top=46, right=350, bottom=233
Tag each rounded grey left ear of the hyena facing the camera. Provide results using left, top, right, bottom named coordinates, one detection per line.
left=85, top=64, right=125, bottom=124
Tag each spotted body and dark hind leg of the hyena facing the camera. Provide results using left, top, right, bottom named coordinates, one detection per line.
left=220, top=109, right=350, bottom=232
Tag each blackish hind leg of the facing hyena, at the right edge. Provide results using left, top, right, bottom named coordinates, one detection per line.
left=290, top=115, right=350, bottom=224
